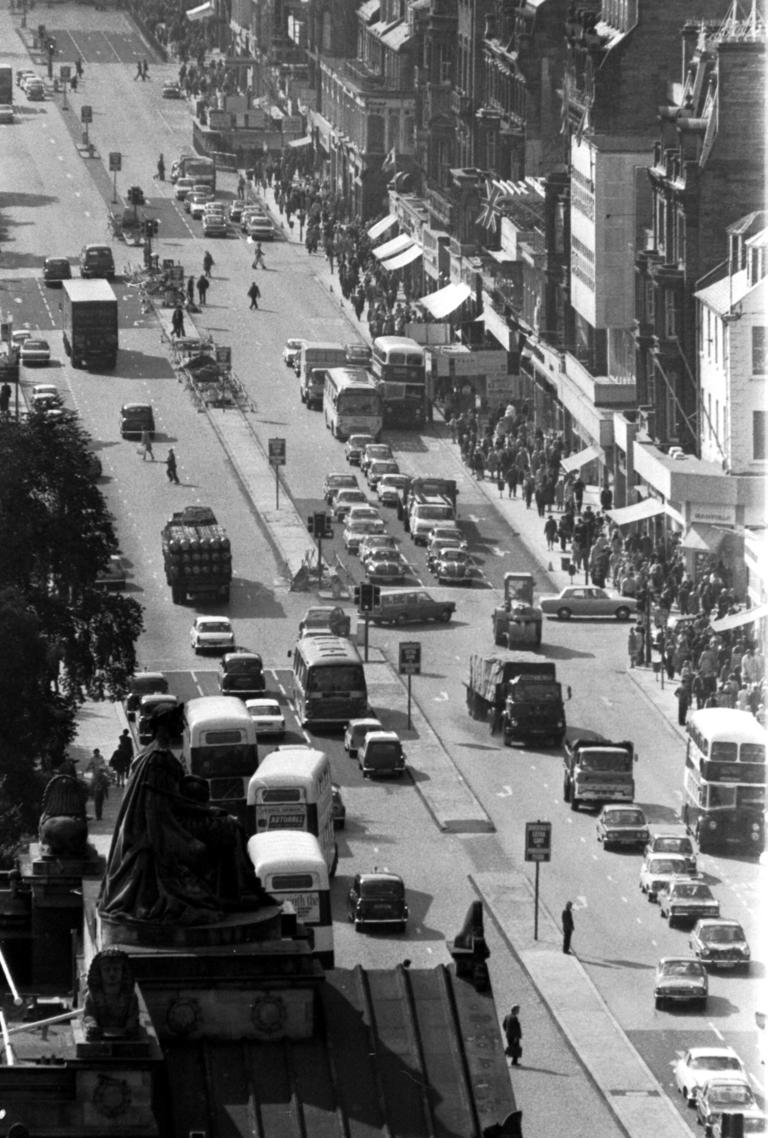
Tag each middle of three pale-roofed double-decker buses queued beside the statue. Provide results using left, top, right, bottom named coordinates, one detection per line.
left=247, top=743, right=338, bottom=876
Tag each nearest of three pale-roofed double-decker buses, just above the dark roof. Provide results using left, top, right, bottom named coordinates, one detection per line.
left=248, top=830, right=335, bottom=968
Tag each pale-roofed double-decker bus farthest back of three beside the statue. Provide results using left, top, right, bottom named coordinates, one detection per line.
left=182, top=695, right=258, bottom=825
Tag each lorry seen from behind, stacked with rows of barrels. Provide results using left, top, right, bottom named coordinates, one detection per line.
left=162, top=505, right=232, bottom=604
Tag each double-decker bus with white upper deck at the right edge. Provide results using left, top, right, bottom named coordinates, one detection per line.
left=683, top=708, right=768, bottom=852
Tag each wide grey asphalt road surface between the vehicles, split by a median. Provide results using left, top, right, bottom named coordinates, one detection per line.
left=0, top=14, right=765, bottom=1135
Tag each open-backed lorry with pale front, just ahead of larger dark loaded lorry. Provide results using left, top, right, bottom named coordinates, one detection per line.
left=563, top=733, right=637, bottom=810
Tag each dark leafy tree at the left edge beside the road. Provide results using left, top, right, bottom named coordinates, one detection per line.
left=0, top=411, right=143, bottom=842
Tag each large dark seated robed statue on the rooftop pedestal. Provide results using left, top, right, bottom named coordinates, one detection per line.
left=99, top=706, right=270, bottom=925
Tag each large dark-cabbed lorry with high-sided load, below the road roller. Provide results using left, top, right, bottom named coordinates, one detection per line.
left=466, top=652, right=571, bottom=747
